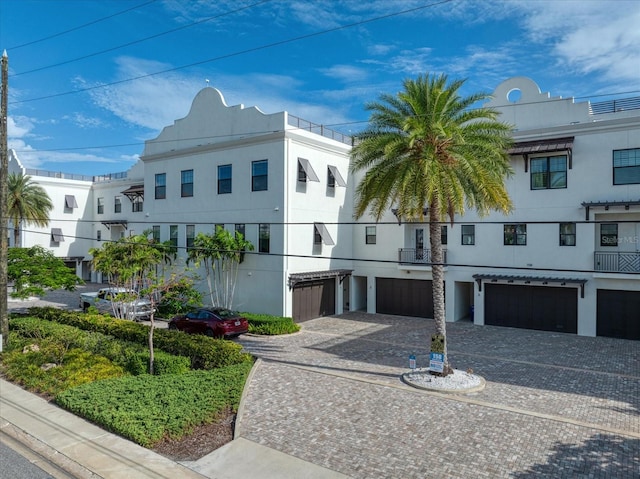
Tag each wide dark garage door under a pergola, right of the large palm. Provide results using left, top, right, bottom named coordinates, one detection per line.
left=484, top=284, right=578, bottom=333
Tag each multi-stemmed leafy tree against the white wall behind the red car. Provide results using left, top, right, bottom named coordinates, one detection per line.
left=188, top=226, right=253, bottom=309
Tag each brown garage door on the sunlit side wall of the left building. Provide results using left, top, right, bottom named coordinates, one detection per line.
left=293, top=278, right=336, bottom=323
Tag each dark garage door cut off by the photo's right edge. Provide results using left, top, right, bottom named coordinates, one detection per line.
left=596, top=289, right=640, bottom=339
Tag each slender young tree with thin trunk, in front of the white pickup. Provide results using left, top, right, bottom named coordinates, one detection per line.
left=89, top=232, right=193, bottom=374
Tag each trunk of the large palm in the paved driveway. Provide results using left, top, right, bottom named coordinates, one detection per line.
left=429, top=204, right=453, bottom=376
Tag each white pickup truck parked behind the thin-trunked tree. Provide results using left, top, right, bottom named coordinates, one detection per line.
left=80, top=287, right=153, bottom=321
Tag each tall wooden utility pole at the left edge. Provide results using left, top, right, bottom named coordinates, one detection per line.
left=0, top=50, right=9, bottom=351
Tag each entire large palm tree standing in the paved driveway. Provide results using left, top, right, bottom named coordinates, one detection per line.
left=351, top=75, right=512, bottom=376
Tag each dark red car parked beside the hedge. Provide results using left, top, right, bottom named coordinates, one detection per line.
left=169, top=308, right=249, bottom=338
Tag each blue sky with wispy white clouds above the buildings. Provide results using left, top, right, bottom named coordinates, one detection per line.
left=0, top=0, right=640, bottom=175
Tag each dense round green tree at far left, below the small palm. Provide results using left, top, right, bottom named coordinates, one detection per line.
left=7, top=246, right=82, bottom=299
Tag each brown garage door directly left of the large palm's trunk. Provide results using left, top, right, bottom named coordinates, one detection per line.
left=376, top=278, right=433, bottom=318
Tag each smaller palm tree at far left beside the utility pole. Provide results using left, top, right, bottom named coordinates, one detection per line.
left=7, top=173, right=53, bottom=246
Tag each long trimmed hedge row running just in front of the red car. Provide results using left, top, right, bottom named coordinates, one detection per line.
left=29, top=307, right=253, bottom=369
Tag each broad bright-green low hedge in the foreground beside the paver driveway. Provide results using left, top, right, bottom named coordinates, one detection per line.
left=55, top=362, right=251, bottom=447
